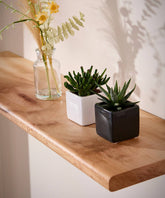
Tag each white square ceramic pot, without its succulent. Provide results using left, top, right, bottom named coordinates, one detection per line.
left=66, top=91, right=100, bottom=126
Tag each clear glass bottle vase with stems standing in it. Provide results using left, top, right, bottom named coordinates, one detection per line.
left=33, top=49, right=62, bottom=100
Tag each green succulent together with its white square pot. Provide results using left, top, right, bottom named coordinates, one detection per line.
left=64, top=66, right=110, bottom=126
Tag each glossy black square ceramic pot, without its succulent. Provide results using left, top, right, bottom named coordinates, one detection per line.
left=95, top=103, right=139, bottom=143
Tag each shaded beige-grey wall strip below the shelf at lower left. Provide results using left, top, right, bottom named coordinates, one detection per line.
left=0, top=115, right=30, bottom=198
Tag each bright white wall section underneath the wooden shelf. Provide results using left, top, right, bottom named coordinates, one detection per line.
left=29, top=133, right=165, bottom=198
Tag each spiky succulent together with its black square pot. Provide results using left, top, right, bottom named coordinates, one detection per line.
left=95, top=79, right=139, bottom=142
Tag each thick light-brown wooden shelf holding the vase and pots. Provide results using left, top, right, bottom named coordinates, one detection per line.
left=0, top=52, right=165, bottom=191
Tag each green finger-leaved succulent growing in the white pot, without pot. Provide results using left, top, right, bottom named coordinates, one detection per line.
left=64, top=66, right=110, bottom=96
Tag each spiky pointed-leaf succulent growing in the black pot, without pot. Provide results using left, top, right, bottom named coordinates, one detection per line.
left=97, top=79, right=138, bottom=111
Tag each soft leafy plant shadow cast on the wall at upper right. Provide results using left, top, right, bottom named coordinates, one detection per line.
left=101, top=0, right=165, bottom=102
